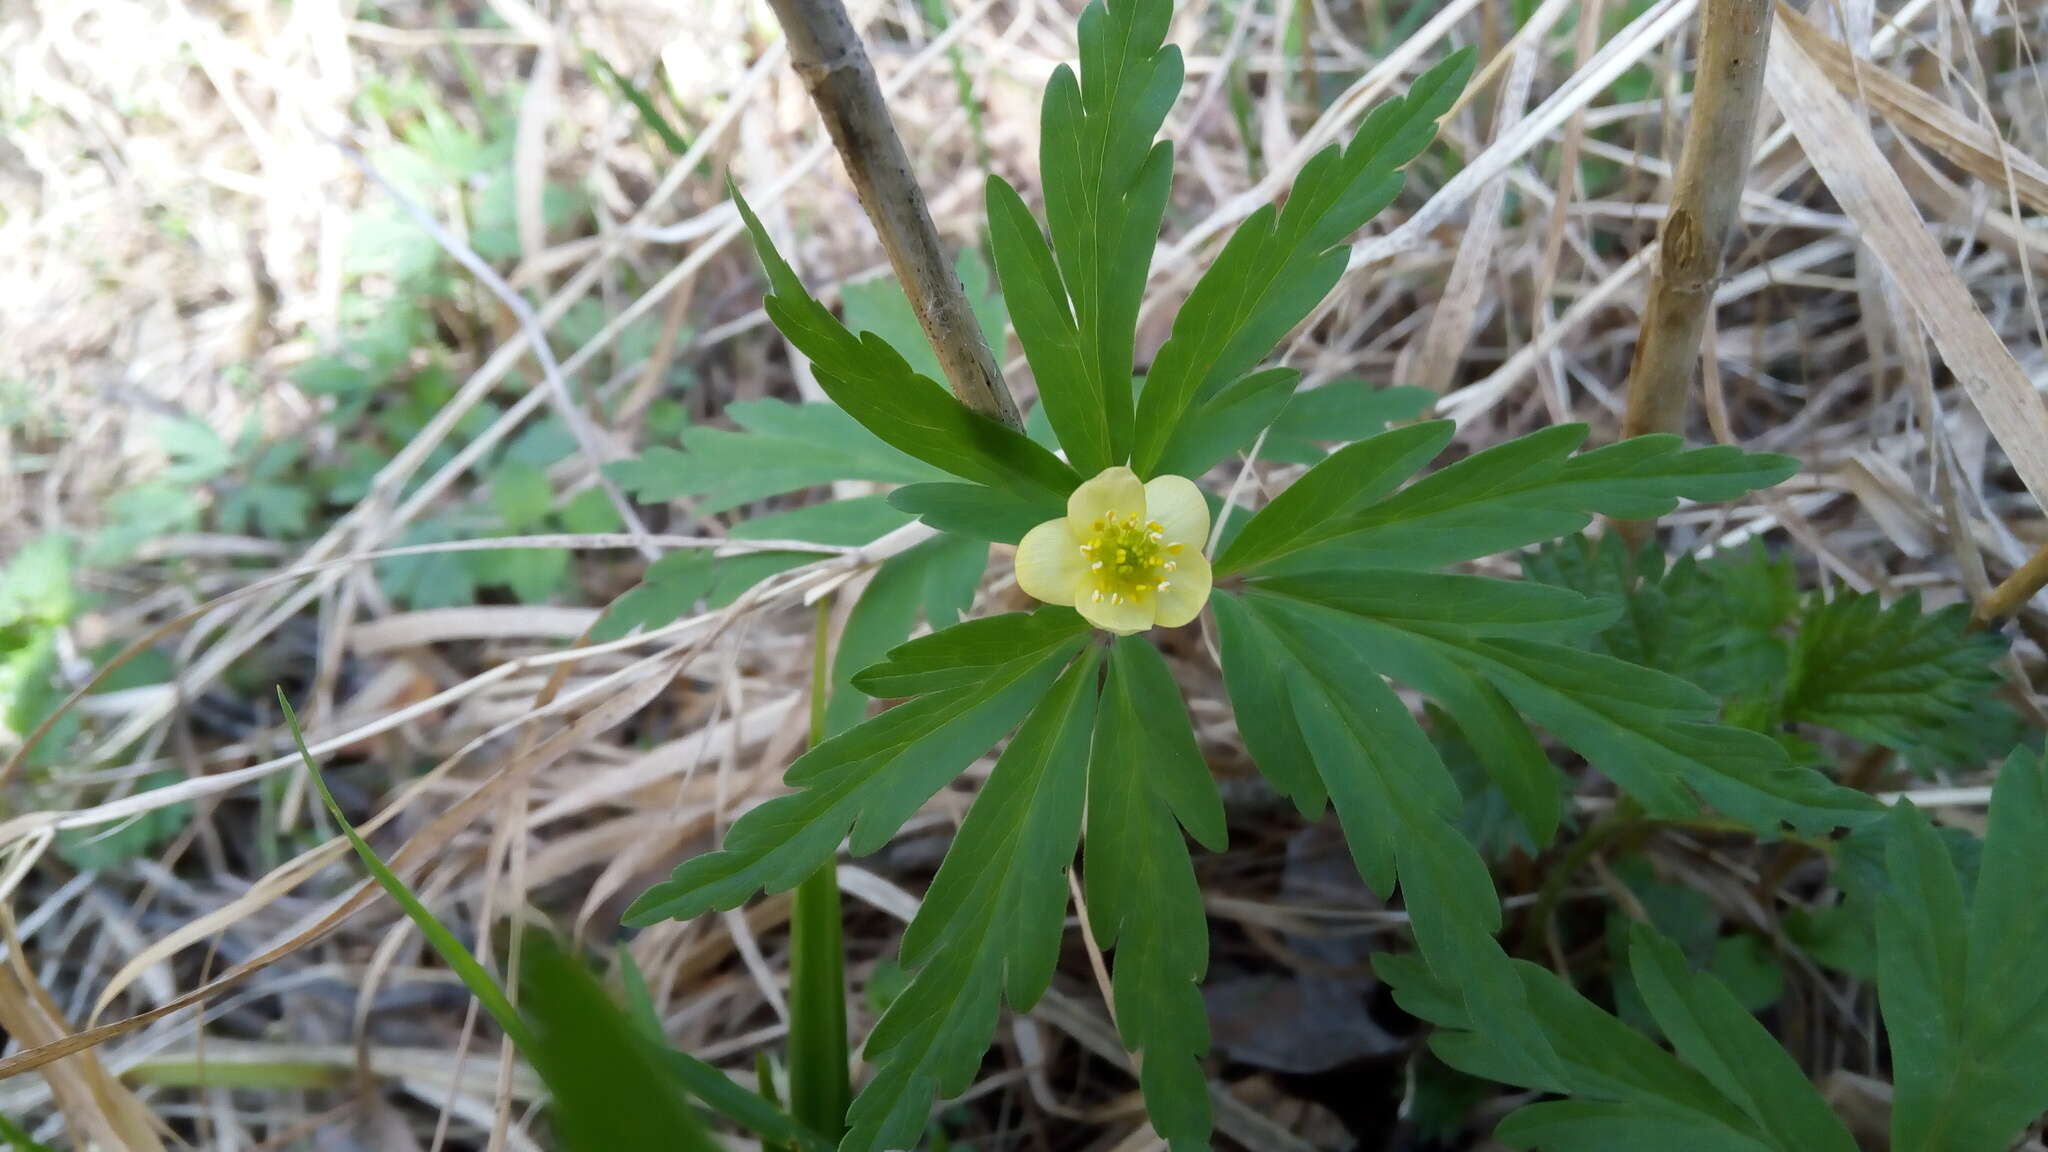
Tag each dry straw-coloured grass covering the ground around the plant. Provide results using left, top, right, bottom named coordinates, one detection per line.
left=0, top=0, right=2048, bottom=1150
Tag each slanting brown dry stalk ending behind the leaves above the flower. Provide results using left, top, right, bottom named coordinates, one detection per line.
left=770, top=0, right=1024, bottom=428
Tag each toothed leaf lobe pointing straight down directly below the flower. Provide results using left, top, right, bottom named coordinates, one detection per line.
left=1083, top=635, right=1223, bottom=1152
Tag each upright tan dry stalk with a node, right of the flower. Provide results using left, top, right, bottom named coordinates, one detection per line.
left=1622, top=0, right=1772, bottom=437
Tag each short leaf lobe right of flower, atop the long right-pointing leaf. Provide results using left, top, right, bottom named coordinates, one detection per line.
left=1217, top=420, right=1456, bottom=576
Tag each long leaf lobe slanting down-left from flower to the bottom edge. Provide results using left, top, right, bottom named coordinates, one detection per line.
left=842, top=650, right=1096, bottom=1152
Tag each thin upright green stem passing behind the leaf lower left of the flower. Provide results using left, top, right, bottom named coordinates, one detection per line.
left=788, top=596, right=852, bottom=1140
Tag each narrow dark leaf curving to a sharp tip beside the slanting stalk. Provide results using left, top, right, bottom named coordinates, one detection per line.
left=733, top=189, right=1081, bottom=498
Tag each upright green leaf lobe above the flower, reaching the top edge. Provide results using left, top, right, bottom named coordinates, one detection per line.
left=1040, top=0, right=1187, bottom=471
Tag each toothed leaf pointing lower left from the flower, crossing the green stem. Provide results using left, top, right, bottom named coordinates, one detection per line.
left=627, top=609, right=1087, bottom=924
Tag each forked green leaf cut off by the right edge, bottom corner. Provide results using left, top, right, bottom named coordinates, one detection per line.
left=1878, top=752, right=2048, bottom=1152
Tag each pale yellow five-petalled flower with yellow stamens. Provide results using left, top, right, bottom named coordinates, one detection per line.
left=1018, top=467, right=1208, bottom=633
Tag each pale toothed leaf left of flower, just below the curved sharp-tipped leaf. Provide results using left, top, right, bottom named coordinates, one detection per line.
left=606, top=400, right=946, bottom=512
